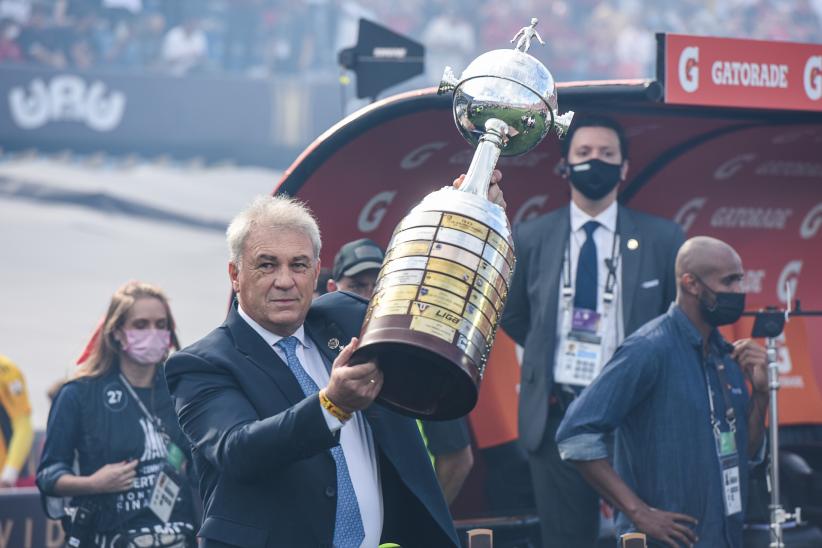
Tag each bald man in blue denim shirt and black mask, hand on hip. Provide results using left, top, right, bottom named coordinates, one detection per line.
left=557, top=237, right=769, bottom=548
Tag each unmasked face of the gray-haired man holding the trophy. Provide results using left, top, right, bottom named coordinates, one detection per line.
left=233, top=226, right=320, bottom=337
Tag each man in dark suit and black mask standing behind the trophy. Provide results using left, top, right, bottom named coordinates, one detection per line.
left=502, top=117, right=684, bottom=548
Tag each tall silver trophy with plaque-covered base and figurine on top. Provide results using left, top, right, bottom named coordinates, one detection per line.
left=355, top=19, right=573, bottom=419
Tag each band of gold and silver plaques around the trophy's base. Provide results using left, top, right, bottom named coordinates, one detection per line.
left=366, top=211, right=514, bottom=374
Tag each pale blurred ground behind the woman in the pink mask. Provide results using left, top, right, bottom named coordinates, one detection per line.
left=0, top=156, right=280, bottom=428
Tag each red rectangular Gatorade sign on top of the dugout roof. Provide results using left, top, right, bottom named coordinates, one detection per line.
left=658, top=34, right=822, bottom=111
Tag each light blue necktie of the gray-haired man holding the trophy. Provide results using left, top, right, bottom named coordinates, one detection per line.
left=277, top=337, right=365, bottom=548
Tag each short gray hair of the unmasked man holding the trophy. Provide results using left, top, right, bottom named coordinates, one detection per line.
left=230, top=194, right=322, bottom=265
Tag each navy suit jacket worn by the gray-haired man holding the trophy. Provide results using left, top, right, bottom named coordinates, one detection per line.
left=166, top=292, right=459, bottom=548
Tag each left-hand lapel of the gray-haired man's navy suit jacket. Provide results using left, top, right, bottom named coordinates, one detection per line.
left=226, top=302, right=305, bottom=405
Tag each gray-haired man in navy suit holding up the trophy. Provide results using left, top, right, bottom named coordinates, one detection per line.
left=166, top=196, right=459, bottom=548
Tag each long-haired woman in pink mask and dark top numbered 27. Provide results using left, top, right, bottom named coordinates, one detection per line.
left=37, top=282, right=196, bottom=548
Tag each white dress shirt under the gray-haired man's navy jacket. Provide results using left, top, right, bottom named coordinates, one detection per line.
left=237, top=306, right=383, bottom=548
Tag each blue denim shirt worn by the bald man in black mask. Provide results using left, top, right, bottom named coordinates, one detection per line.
left=557, top=303, right=764, bottom=548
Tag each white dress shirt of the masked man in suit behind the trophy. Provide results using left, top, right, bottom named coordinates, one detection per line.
left=554, top=201, right=625, bottom=384
